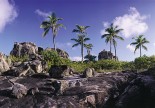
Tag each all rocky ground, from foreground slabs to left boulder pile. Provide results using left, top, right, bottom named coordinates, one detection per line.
left=0, top=43, right=155, bottom=108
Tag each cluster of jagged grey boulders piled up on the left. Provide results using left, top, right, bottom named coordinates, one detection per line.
left=0, top=42, right=69, bottom=76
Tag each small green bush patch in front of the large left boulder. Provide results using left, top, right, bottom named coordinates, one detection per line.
left=9, top=55, right=29, bottom=63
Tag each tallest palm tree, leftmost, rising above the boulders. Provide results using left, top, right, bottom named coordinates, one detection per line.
left=40, top=13, right=64, bottom=50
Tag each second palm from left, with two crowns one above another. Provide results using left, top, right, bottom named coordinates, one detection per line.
left=71, top=25, right=90, bottom=63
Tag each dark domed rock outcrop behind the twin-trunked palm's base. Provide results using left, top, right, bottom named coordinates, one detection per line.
left=98, top=50, right=118, bottom=60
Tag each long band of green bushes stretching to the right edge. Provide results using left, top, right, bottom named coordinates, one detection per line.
left=42, top=51, right=155, bottom=72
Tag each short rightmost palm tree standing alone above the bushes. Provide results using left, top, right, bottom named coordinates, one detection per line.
left=130, top=35, right=149, bottom=57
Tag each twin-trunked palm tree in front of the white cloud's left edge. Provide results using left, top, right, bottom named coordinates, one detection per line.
left=101, top=23, right=124, bottom=60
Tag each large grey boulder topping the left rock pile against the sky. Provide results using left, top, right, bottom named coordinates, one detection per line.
left=10, top=42, right=38, bottom=57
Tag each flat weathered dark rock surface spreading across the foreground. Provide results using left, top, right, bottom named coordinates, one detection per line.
left=0, top=69, right=155, bottom=108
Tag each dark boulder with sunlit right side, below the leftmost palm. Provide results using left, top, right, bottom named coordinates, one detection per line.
left=49, top=65, right=73, bottom=78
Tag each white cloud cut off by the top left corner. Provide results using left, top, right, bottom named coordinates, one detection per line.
left=0, top=0, right=18, bottom=32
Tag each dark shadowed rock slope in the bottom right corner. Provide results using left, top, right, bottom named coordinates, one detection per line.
left=115, top=76, right=155, bottom=108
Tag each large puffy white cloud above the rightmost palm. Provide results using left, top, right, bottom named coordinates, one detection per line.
left=113, top=7, right=148, bottom=38
